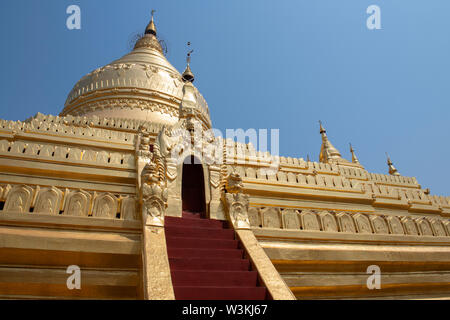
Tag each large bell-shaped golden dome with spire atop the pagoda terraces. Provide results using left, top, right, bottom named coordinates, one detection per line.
left=61, top=14, right=211, bottom=127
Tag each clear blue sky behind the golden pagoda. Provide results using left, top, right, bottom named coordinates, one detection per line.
left=0, top=0, right=450, bottom=195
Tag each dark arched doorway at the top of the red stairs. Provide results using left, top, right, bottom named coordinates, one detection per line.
left=181, top=156, right=205, bottom=216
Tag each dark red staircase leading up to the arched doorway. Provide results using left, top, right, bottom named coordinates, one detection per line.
left=165, top=212, right=266, bottom=300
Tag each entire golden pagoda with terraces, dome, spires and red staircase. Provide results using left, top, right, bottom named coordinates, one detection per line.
left=0, top=12, right=450, bottom=300
